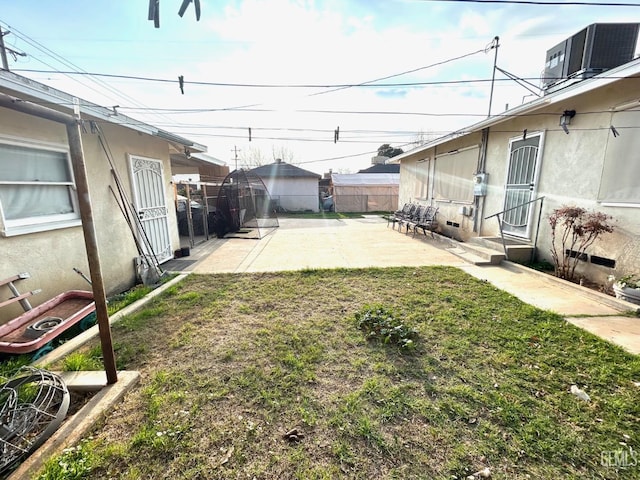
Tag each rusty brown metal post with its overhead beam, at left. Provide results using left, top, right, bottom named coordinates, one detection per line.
left=0, top=93, right=118, bottom=384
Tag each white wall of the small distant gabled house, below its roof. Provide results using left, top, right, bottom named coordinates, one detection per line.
left=262, top=177, right=320, bottom=212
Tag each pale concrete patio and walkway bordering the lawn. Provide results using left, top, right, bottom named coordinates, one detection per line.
left=164, top=215, right=640, bottom=354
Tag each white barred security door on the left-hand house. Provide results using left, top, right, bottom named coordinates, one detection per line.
left=129, top=155, right=172, bottom=263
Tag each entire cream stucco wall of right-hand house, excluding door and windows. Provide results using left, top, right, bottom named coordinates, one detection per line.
left=399, top=79, right=640, bottom=284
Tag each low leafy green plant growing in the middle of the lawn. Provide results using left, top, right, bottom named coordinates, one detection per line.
left=355, top=305, right=418, bottom=350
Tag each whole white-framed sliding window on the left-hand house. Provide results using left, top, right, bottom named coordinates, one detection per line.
left=0, top=139, right=80, bottom=236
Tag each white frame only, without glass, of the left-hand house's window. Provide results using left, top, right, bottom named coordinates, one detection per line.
left=0, top=135, right=82, bottom=237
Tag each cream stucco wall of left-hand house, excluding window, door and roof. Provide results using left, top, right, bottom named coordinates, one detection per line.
left=0, top=109, right=179, bottom=323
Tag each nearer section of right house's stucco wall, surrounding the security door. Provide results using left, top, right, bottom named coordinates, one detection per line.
left=480, top=78, right=640, bottom=283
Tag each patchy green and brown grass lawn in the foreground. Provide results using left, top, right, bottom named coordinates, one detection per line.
left=39, top=267, right=640, bottom=480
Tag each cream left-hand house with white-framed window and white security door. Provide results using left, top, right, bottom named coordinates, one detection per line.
left=0, top=71, right=210, bottom=323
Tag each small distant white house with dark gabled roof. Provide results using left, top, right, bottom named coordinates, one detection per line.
left=249, top=160, right=320, bottom=212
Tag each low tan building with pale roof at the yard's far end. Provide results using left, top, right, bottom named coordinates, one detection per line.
left=331, top=173, right=400, bottom=212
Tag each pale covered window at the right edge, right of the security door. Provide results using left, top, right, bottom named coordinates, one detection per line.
left=598, top=109, right=640, bottom=207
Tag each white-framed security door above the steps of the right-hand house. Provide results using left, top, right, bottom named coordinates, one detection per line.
left=502, top=133, right=543, bottom=238
